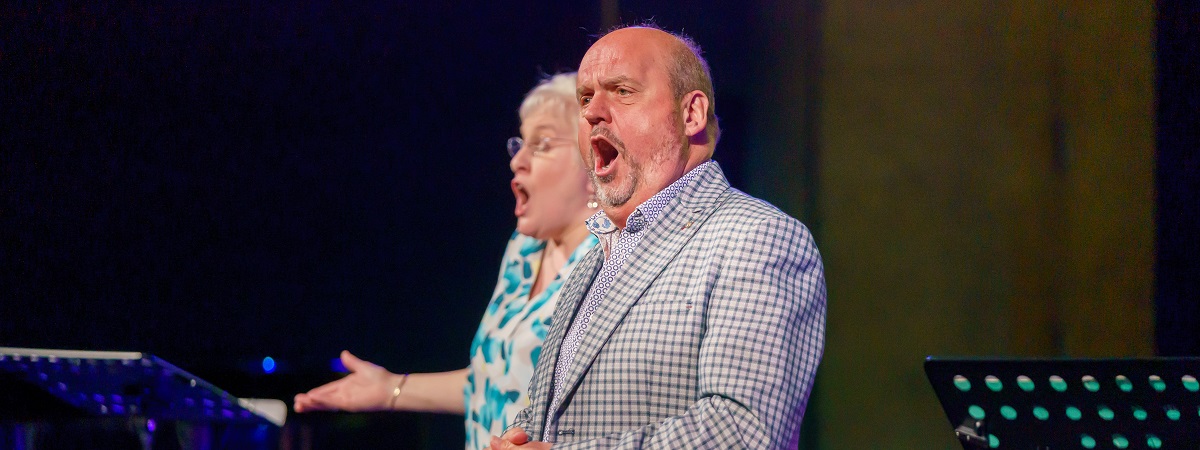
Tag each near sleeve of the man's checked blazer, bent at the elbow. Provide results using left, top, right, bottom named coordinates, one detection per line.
left=554, top=215, right=826, bottom=449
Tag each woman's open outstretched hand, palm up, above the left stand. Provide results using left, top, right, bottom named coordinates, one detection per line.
left=295, top=350, right=401, bottom=413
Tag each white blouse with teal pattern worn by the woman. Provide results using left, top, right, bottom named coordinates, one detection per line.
left=463, top=233, right=598, bottom=450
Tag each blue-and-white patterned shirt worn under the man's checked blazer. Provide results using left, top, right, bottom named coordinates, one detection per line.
left=542, top=161, right=714, bottom=440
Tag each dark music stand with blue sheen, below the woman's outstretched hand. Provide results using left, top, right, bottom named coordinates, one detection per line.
left=0, top=347, right=287, bottom=448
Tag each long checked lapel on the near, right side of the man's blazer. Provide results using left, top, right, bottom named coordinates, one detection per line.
left=549, top=163, right=730, bottom=415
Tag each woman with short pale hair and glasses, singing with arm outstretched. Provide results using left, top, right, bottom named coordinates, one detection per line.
left=295, top=73, right=596, bottom=449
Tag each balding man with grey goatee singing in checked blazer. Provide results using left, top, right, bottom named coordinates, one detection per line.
left=492, top=28, right=826, bottom=449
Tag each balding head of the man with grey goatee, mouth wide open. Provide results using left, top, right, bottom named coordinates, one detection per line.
left=576, top=26, right=718, bottom=227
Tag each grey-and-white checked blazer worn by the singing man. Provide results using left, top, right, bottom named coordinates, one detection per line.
left=515, top=163, right=826, bottom=449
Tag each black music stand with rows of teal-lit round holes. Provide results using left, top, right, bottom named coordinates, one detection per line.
left=925, top=356, right=1200, bottom=450
